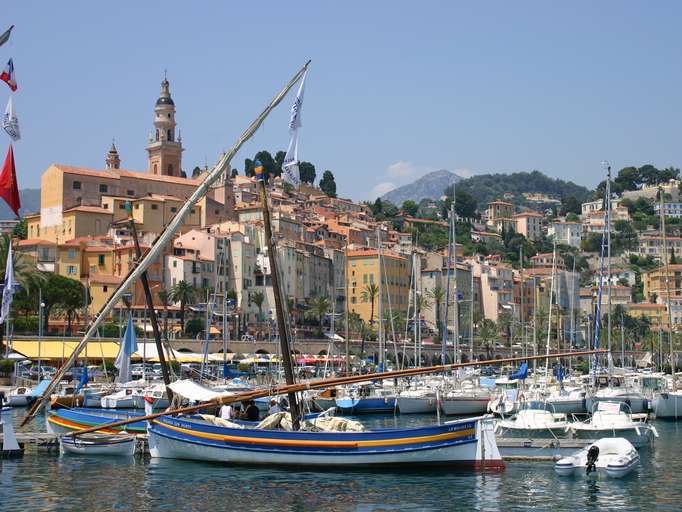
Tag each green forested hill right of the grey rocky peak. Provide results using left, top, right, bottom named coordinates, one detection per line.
left=457, top=171, right=592, bottom=210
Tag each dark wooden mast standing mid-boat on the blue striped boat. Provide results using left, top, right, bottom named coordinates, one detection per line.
left=255, top=160, right=301, bottom=430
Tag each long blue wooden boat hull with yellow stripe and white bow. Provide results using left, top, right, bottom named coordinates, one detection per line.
left=148, top=416, right=504, bottom=469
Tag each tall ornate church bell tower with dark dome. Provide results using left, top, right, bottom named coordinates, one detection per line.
left=147, top=76, right=182, bottom=177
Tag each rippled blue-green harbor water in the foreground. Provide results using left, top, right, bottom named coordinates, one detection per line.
left=0, top=410, right=682, bottom=512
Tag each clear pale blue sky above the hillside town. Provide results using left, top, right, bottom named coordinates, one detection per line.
left=5, top=0, right=682, bottom=199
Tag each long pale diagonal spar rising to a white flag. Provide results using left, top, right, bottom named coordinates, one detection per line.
left=21, top=61, right=310, bottom=425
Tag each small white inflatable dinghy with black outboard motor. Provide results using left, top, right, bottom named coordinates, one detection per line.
left=554, top=437, right=639, bottom=478
